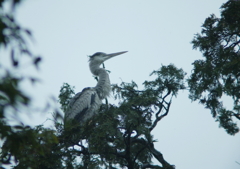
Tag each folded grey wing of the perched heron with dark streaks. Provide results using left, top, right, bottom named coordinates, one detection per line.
left=65, top=88, right=101, bottom=122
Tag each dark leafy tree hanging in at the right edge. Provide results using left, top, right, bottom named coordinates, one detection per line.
left=188, top=0, right=240, bottom=135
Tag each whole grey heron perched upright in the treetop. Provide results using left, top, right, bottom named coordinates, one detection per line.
left=65, top=51, right=127, bottom=125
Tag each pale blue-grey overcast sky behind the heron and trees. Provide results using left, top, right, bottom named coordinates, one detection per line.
left=2, top=0, right=240, bottom=169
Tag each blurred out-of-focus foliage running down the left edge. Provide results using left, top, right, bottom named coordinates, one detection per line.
left=0, top=0, right=58, bottom=168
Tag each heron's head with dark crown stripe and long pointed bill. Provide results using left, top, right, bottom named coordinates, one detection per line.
left=89, top=51, right=127, bottom=64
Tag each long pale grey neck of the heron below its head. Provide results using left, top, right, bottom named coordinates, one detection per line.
left=95, top=68, right=111, bottom=99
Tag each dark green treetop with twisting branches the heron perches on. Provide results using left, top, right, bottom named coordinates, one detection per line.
left=60, top=65, right=185, bottom=169
